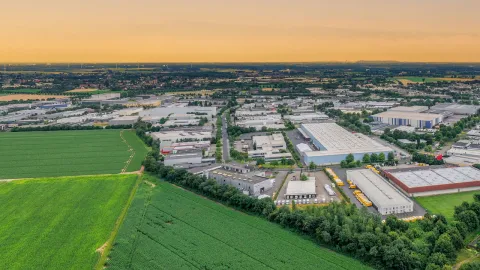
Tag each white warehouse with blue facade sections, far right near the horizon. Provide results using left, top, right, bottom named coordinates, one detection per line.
left=370, top=111, right=443, bottom=128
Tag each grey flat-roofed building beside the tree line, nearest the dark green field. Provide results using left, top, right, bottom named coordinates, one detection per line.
left=206, top=164, right=274, bottom=196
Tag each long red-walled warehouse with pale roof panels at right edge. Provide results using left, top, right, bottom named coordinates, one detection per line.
left=383, top=167, right=480, bottom=197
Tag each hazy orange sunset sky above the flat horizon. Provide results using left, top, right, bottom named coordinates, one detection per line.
left=0, top=0, right=480, bottom=63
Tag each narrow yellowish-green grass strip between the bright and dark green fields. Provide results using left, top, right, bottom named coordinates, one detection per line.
left=94, top=174, right=143, bottom=270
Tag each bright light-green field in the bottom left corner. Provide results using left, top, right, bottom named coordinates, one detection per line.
left=0, top=174, right=138, bottom=269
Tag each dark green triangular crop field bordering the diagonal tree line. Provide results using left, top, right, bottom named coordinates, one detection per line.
left=107, top=176, right=369, bottom=270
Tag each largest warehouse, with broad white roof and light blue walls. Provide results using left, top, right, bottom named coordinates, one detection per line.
left=300, top=123, right=393, bottom=165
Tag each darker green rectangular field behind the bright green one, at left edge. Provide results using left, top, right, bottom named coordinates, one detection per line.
left=0, top=130, right=148, bottom=179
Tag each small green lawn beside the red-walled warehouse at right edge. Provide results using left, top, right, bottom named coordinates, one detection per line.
left=416, top=191, right=480, bottom=220
